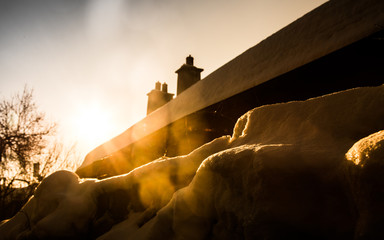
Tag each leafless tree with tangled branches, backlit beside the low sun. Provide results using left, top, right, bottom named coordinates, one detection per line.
left=0, top=87, right=76, bottom=220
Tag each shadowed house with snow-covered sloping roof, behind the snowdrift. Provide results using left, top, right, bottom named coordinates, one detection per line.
left=77, top=0, right=384, bottom=178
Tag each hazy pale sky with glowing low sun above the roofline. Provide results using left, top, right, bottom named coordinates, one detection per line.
left=0, top=0, right=325, bottom=157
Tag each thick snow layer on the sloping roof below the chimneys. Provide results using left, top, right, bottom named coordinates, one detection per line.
left=80, top=0, right=384, bottom=168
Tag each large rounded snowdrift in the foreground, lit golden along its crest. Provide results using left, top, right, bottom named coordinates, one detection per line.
left=0, top=86, right=384, bottom=240
